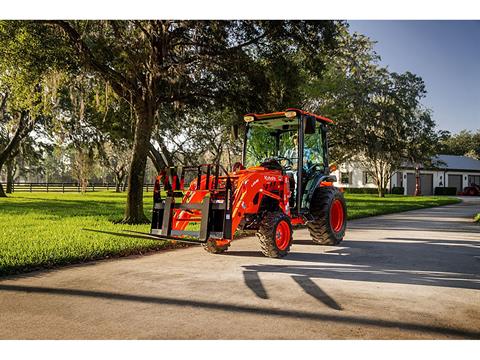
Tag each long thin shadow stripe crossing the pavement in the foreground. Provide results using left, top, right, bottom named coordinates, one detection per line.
left=0, top=283, right=480, bottom=339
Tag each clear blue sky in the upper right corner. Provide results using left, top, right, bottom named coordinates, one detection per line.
left=348, top=20, right=480, bottom=133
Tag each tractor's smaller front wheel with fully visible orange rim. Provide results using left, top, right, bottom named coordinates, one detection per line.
left=257, top=211, right=293, bottom=258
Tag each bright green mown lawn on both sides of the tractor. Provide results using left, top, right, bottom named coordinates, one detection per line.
left=0, top=192, right=459, bottom=275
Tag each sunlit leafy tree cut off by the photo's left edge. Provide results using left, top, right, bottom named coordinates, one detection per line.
left=0, top=21, right=69, bottom=197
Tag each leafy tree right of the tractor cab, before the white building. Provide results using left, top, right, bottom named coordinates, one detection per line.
left=307, top=27, right=443, bottom=197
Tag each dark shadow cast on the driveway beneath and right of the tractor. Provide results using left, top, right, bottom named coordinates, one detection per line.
left=225, top=237, right=480, bottom=310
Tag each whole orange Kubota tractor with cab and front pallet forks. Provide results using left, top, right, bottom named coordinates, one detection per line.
left=150, top=109, right=347, bottom=258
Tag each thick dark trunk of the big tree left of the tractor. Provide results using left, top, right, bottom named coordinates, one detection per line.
left=122, top=101, right=155, bottom=224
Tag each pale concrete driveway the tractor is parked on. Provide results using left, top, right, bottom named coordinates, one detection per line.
left=0, top=199, right=480, bottom=339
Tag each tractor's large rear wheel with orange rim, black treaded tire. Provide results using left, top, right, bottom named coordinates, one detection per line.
left=307, top=187, right=347, bottom=245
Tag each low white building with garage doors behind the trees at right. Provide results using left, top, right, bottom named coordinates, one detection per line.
left=334, top=155, right=480, bottom=195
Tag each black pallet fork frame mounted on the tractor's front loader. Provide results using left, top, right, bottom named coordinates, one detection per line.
left=150, top=164, right=233, bottom=244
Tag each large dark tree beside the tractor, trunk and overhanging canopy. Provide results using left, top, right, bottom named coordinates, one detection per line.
left=42, top=21, right=342, bottom=223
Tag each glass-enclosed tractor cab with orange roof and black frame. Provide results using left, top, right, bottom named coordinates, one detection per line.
left=242, top=109, right=336, bottom=214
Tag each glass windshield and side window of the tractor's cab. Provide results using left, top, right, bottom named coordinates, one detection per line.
left=244, top=119, right=324, bottom=169
